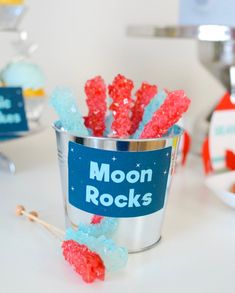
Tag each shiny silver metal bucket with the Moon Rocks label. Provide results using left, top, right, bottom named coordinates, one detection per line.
left=53, top=122, right=183, bottom=253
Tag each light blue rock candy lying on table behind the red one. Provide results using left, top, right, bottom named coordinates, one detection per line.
left=65, top=228, right=128, bottom=272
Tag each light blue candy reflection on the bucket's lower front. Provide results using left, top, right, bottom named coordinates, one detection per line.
left=78, top=217, right=118, bottom=238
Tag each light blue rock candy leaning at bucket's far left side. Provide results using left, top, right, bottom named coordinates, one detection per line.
left=50, top=88, right=89, bottom=135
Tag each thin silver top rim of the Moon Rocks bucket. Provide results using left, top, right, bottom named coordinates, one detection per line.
left=52, top=120, right=184, bottom=142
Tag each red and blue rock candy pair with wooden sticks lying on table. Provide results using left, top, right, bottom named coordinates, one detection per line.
left=16, top=205, right=128, bottom=283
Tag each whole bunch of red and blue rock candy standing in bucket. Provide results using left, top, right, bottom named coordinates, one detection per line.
left=51, top=74, right=190, bottom=139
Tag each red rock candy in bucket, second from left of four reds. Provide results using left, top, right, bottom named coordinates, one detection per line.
left=109, top=74, right=134, bottom=137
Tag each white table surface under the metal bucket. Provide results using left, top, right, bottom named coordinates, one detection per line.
left=0, top=128, right=235, bottom=293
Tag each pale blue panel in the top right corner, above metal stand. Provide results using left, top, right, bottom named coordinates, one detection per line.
left=179, top=0, right=235, bottom=26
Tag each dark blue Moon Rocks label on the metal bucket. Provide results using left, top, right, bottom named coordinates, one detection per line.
left=68, top=142, right=171, bottom=218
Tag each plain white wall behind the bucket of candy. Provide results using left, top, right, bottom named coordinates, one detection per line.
left=0, top=0, right=224, bottom=118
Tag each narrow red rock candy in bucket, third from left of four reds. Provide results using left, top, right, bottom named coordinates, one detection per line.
left=130, top=82, right=157, bottom=135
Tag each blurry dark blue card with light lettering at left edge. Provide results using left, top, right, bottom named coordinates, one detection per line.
left=0, top=87, right=29, bottom=136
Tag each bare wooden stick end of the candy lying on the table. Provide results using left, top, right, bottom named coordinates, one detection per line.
left=16, top=205, right=65, bottom=238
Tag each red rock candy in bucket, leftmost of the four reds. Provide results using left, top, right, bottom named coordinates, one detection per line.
left=85, top=76, right=107, bottom=136
